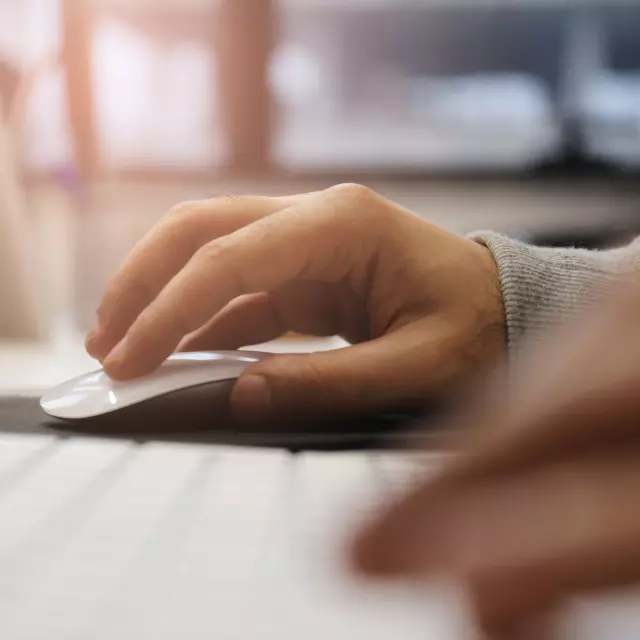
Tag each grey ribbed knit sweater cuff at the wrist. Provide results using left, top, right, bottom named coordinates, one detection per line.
left=471, top=232, right=640, bottom=351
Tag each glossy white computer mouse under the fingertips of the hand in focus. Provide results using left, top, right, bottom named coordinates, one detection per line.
left=40, top=351, right=270, bottom=420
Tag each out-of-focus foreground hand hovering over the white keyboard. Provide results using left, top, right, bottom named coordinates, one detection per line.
left=352, top=283, right=640, bottom=637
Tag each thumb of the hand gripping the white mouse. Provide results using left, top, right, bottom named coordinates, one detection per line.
left=231, top=327, right=464, bottom=425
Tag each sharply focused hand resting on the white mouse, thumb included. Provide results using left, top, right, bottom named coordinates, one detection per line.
left=87, top=185, right=506, bottom=421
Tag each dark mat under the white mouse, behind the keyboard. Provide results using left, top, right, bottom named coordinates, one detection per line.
left=0, top=393, right=440, bottom=451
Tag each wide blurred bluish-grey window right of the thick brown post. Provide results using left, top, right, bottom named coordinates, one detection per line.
left=270, top=0, right=640, bottom=172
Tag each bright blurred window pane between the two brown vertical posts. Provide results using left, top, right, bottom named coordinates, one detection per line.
left=93, top=3, right=224, bottom=170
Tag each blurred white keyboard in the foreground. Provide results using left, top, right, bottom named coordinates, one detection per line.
left=0, top=436, right=640, bottom=640
